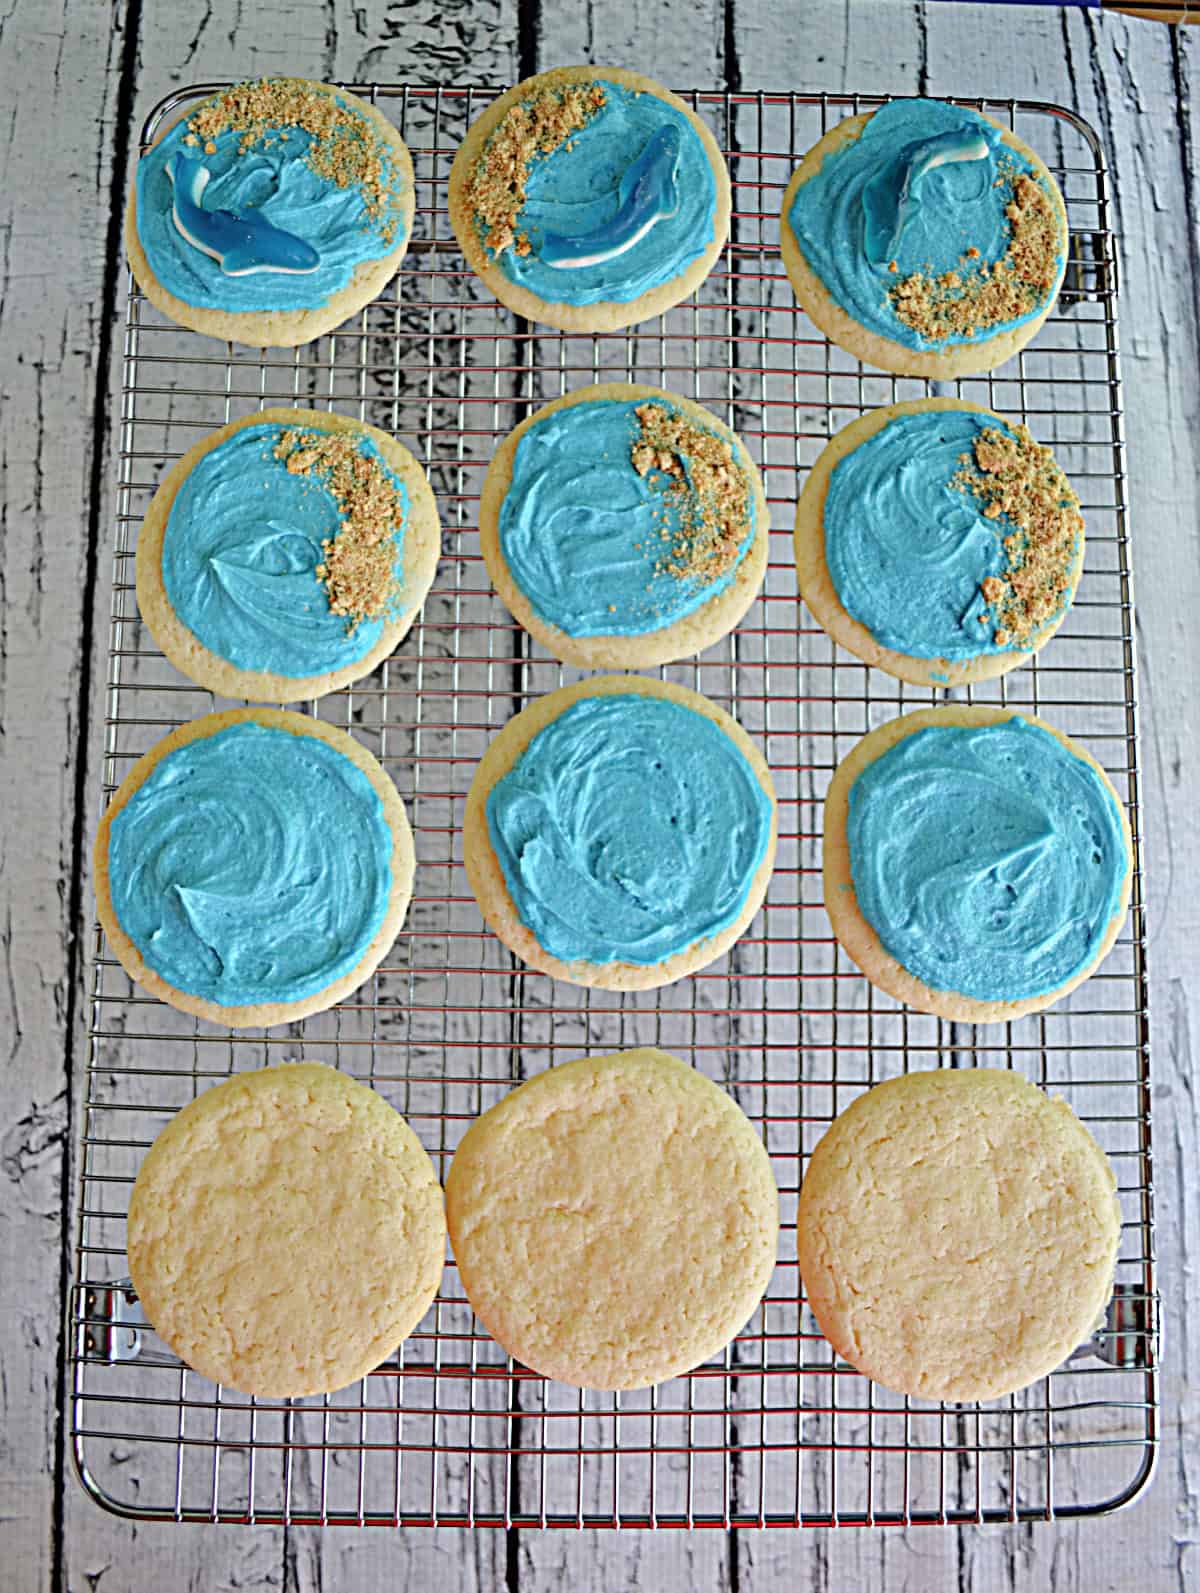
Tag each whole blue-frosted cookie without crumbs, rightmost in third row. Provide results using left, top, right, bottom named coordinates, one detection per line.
left=824, top=704, right=1133, bottom=1023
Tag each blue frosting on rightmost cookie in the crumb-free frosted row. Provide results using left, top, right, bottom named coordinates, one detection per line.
left=846, top=717, right=1128, bottom=1000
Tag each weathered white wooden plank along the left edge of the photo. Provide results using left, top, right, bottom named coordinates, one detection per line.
left=0, top=0, right=159, bottom=1588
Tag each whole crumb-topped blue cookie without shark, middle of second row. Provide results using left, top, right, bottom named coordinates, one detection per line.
left=480, top=382, right=770, bottom=669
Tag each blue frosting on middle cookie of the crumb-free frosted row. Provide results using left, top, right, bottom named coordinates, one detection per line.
left=488, top=693, right=771, bottom=965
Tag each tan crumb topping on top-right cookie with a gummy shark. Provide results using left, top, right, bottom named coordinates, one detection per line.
left=888, top=159, right=1060, bottom=342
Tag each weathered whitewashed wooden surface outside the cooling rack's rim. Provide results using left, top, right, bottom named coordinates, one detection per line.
left=0, top=0, right=1200, bottom=1593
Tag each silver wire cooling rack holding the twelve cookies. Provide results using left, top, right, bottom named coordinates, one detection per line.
left=67, top=84, right=1155, bottom=1528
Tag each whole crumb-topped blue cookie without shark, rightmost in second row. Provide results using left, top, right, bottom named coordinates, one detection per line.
left=795, top=398, right=1084, bottom=688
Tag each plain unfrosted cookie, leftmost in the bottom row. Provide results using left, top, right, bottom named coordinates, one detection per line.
left=127, top=1063, right=446, bottom=1399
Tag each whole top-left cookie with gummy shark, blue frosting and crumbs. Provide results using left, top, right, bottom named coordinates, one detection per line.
left=124, top=78, right=414, bottom=349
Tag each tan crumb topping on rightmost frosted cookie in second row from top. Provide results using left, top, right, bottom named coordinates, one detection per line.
left=950, top=425, right=1084, bottom=648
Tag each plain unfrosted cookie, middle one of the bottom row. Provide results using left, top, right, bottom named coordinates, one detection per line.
left=446, top=1050, right=779, bottom=1389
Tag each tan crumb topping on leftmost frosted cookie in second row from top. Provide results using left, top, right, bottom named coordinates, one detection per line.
left=274, top=427, right=405, bottom=636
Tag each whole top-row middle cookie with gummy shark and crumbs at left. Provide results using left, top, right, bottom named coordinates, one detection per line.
left=449, top=67, right=730, bottom=331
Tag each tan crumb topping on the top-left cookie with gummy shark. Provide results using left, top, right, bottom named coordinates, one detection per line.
left=183, top=78, right=398, bottom=244
